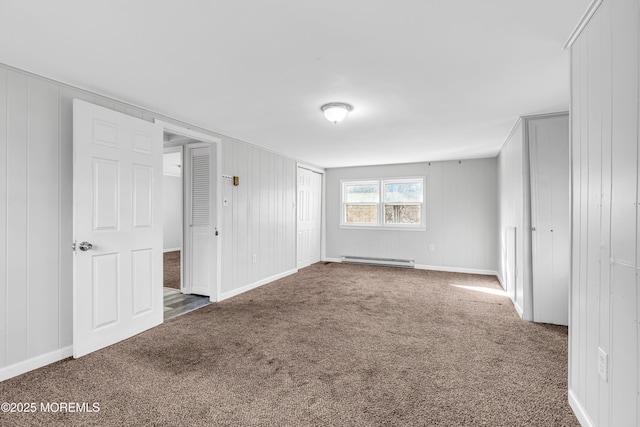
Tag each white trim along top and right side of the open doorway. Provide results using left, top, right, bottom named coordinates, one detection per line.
left=154, top=119, right=222, bottom=302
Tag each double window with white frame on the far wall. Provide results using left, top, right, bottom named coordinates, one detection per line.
left=340, top=177, right=425, bottom=229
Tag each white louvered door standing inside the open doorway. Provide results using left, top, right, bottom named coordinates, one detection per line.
left=184, top=144, right=215, bottom=296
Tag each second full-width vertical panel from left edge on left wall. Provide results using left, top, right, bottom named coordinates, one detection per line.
left=27, top=79, right=60, bottom=357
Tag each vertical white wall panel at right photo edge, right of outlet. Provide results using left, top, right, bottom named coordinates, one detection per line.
left=611, top=0, right=638, bottom=426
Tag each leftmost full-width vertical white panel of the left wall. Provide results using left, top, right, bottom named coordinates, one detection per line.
left=7, top=71, right=28, bottom=365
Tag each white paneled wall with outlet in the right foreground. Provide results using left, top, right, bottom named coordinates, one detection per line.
left=569, top=0, right=640, bottom=427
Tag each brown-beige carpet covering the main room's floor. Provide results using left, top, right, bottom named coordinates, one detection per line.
left=0, top=264, right=578, bottom=426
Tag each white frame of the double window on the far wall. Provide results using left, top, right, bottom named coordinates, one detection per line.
left=340, top=176, right=427, bottom=231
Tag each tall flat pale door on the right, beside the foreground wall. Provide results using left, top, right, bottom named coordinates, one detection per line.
left=528, top=116, right=571, bottom=325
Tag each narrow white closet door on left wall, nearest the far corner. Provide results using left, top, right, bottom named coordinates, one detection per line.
left=297, top=167, right=322, bottom=268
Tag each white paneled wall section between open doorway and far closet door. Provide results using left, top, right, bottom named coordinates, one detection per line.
left=221, top=139, right=296, bottom=298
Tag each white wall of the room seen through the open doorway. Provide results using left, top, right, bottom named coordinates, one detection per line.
left=162, top=175, right=182, bottom=252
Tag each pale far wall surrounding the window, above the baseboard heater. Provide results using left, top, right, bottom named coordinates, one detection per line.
left=326, top=158, right=498, bottom=274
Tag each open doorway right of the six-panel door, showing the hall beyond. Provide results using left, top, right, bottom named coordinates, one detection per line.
left=158, top=123, right=219, bottom=320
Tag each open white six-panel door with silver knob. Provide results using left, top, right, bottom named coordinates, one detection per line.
left=73, top=99, right=163, bottom=357
